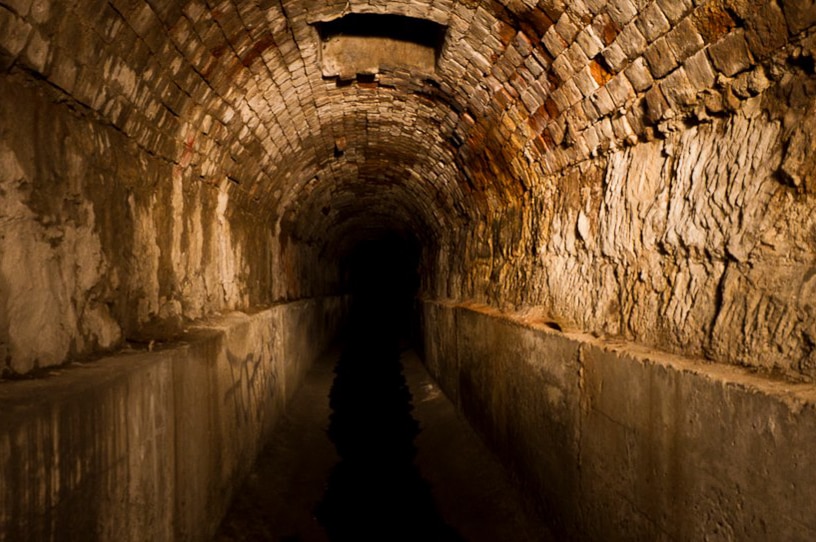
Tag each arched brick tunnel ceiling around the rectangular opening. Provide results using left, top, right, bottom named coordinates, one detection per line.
left=0, top=0, right=814, bottom=255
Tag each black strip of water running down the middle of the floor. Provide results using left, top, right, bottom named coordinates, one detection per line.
left=316, top=307, right=462, bottom=541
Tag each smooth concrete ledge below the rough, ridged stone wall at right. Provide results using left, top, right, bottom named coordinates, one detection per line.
left=423, top=302, right=816, bottom=540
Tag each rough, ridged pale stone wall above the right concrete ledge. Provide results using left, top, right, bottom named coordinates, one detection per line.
left=435, top=60, right=816, bottom=381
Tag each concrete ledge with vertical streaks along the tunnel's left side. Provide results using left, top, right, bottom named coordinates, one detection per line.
left=0, top=298, right=345, bottom=541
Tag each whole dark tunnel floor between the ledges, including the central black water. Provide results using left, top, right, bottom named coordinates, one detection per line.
left=214, top=339, right=553, bottom=542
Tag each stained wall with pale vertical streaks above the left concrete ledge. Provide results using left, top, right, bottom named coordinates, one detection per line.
left=0, top=72, right=338, bottom=377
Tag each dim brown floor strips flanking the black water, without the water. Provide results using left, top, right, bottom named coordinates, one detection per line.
left=215, top=351, right=553, bottom=542
